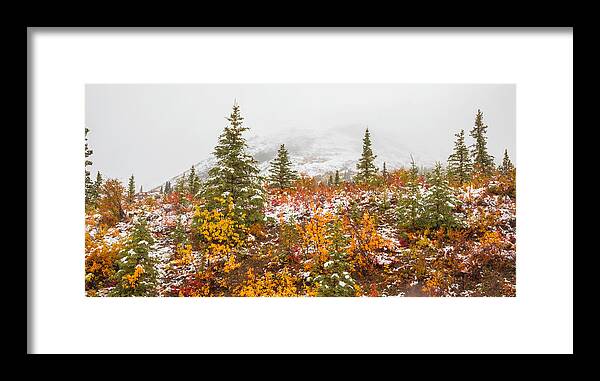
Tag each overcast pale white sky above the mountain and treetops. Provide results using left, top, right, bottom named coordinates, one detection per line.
left=86, top=84, right=516, bottom=190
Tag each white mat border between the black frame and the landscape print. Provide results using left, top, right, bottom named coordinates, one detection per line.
left=28, top=29, right=573, bottom=353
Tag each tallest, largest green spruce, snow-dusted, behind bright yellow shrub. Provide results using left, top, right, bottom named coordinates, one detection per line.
left=203, top=102, right=264, bottom=224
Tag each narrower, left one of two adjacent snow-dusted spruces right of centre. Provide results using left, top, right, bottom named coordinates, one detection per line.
left=398, top=155, right=424, bottom=229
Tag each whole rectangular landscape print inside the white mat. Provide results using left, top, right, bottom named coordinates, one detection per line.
left=81, top=83, right=517, bottom=297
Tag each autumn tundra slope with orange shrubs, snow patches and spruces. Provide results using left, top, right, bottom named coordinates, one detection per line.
left=85, top=104, right=516, bottom=297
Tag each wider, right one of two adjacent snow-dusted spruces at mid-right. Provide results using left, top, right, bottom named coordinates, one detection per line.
left=424, top=162, right=460, bottom=228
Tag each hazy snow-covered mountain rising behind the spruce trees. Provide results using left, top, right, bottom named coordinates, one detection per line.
left=152, top=126, right=434, bottom=188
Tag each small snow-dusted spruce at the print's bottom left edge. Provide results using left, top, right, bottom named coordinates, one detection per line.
left=110, top=219, right=157, bottom=296
